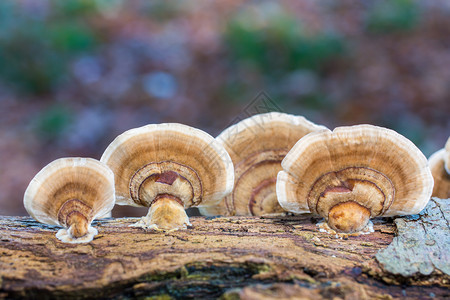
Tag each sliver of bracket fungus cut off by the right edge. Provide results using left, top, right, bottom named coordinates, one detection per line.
left=428, top=137, right=450, bottom=199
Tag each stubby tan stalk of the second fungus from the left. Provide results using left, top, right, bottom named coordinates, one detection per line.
left=133, top=194, right=191, bottom=231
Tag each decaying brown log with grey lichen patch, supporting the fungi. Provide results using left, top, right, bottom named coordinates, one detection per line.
left=0, top=199, right=450, bottom=299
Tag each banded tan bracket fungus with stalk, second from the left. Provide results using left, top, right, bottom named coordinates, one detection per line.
left=101, top=123, right=234, bottom=230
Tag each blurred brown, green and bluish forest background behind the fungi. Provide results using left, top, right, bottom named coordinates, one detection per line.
left=0, top=0, right=450, bottom=216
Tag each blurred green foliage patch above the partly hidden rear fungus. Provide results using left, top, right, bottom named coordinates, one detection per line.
left=226, top=10, right=345, bottom=73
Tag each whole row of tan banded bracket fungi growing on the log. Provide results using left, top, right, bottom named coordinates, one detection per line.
left=24, top=112, right=438, bottom=243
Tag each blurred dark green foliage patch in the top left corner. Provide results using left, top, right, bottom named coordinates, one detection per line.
left=0, top=0, right=98, bottom=95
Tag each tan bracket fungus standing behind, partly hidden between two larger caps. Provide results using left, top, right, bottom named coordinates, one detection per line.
left=200, top=112, right=325, bottom=216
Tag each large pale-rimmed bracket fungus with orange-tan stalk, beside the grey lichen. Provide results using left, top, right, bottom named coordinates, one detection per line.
left=277, top=125, right=433, bottom=234
